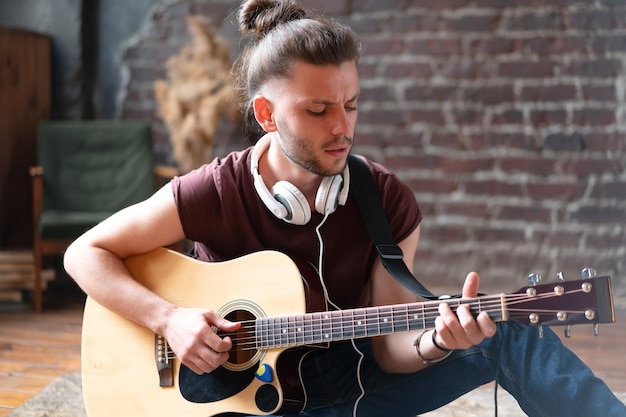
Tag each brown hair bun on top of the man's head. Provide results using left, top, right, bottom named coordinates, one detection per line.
left=237, top=0, right=307, bottom=40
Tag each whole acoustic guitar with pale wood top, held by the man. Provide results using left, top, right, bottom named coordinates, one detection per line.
left=82, top=248, right=615, bottom=417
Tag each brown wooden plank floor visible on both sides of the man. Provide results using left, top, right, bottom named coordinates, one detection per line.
left=0, top=282, right=626, bottom=417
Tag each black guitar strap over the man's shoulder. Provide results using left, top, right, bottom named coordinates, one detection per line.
left=348, top=155, right=439, bottom=300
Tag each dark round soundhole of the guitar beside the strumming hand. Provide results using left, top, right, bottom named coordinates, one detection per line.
left=218, top=310, right=260, bottom=371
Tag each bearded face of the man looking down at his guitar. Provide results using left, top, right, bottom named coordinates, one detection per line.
left=268, top=62, right=360, bottom=176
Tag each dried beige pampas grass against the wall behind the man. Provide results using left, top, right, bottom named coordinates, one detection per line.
left=154, top=16, right=241, bottom=172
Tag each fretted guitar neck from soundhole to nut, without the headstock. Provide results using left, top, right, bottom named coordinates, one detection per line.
left=255, top=295, right=507, bottom=349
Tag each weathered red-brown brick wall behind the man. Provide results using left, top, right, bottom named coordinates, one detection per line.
left=123, top=0, right=626, bottom=295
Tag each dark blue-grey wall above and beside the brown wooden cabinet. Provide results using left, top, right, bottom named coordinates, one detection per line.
left=0, top=0, right=163, bottom=119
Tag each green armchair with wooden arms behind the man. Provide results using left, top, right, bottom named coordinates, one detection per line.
left=30, top=120, right=176, bottom=312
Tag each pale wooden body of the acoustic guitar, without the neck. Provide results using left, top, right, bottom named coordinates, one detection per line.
left=82, top=248, right=324, bottom=417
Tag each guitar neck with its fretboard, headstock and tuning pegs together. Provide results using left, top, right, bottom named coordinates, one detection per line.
left=254, top=276, right=615, bottom=349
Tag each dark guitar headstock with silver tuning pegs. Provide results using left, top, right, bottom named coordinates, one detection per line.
left=506, top=268, right=615, bottom=337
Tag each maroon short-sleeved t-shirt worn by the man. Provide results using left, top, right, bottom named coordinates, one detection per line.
left=172, top=148, right=422, bottom=309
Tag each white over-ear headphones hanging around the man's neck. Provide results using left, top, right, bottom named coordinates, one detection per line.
left=250, top=136, right=350, bottom=225
